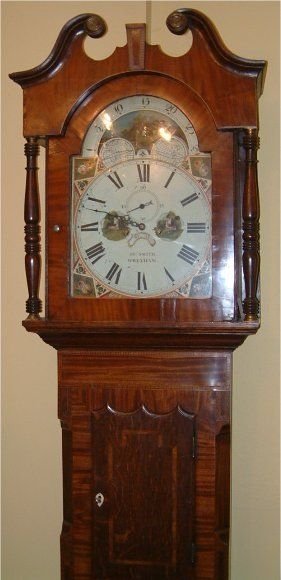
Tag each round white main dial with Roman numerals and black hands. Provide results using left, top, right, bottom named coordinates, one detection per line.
left=74, top=158, right=211, bottom=297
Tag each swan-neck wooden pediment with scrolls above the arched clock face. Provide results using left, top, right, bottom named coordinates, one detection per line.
left=10, top=9, right=266, bottom=137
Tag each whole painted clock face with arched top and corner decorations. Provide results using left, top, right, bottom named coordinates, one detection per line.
left=72, top=95, right=211, bottom=298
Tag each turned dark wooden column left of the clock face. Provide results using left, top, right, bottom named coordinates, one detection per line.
left=24, top=137, right=42, bottom=318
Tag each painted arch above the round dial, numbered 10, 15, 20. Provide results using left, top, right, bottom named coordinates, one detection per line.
left=82, top=95, right=199, bottom=159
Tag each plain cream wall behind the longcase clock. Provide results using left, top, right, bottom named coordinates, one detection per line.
left=2, top=1, right=280, bottom=580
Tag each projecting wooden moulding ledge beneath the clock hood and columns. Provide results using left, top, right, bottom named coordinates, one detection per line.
left=23, top=319, right=259, bottom=351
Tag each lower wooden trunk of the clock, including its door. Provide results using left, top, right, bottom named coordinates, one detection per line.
left=59, top=350, right=232, bottom=580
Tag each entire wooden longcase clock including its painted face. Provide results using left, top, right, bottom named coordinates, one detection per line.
left=10, top=9, right=266, bottom=580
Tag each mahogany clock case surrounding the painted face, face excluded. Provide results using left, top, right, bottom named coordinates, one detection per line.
left=11, top=9, right=266, bottom=580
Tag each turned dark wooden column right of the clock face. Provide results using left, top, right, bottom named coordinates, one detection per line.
left=242, top=129, right=260, bottom=321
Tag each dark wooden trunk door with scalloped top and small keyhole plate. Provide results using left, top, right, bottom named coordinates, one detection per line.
left=92, top=406, right=195, bottom=580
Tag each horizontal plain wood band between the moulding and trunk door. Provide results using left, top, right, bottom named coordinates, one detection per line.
left=59, top=349, right=231, bottom=390
